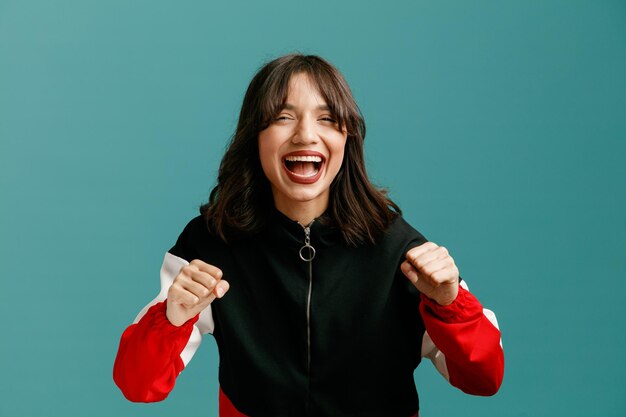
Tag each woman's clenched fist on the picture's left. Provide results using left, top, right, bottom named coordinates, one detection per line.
left=166, top=259, right=229, bottom=326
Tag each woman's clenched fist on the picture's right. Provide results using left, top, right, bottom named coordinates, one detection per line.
left=400, top=242, right=459, bottom=305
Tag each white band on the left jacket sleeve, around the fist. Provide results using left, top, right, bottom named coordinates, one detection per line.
left=133, top=252, right=215, bottom=366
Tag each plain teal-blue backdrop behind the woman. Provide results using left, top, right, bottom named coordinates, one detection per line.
left=0, top=0, right=626, bottom=417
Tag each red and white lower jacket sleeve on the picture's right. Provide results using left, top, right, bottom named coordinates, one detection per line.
left=420, top=281, right=504, bottom=396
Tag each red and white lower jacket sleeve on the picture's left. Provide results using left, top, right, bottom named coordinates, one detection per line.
left=113, top=252, right=214, bottom=402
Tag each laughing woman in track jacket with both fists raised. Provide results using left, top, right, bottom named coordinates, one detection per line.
left=113, top=55, right=504, bottom=417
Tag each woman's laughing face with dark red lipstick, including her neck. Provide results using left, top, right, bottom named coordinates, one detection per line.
left=259, top=73, right=347, bottom=220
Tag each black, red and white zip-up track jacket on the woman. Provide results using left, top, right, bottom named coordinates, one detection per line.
left=114, top=210, right=504, bottom=417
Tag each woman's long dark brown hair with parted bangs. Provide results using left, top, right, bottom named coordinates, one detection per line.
left=200, top=54, right=400, bottom=246
